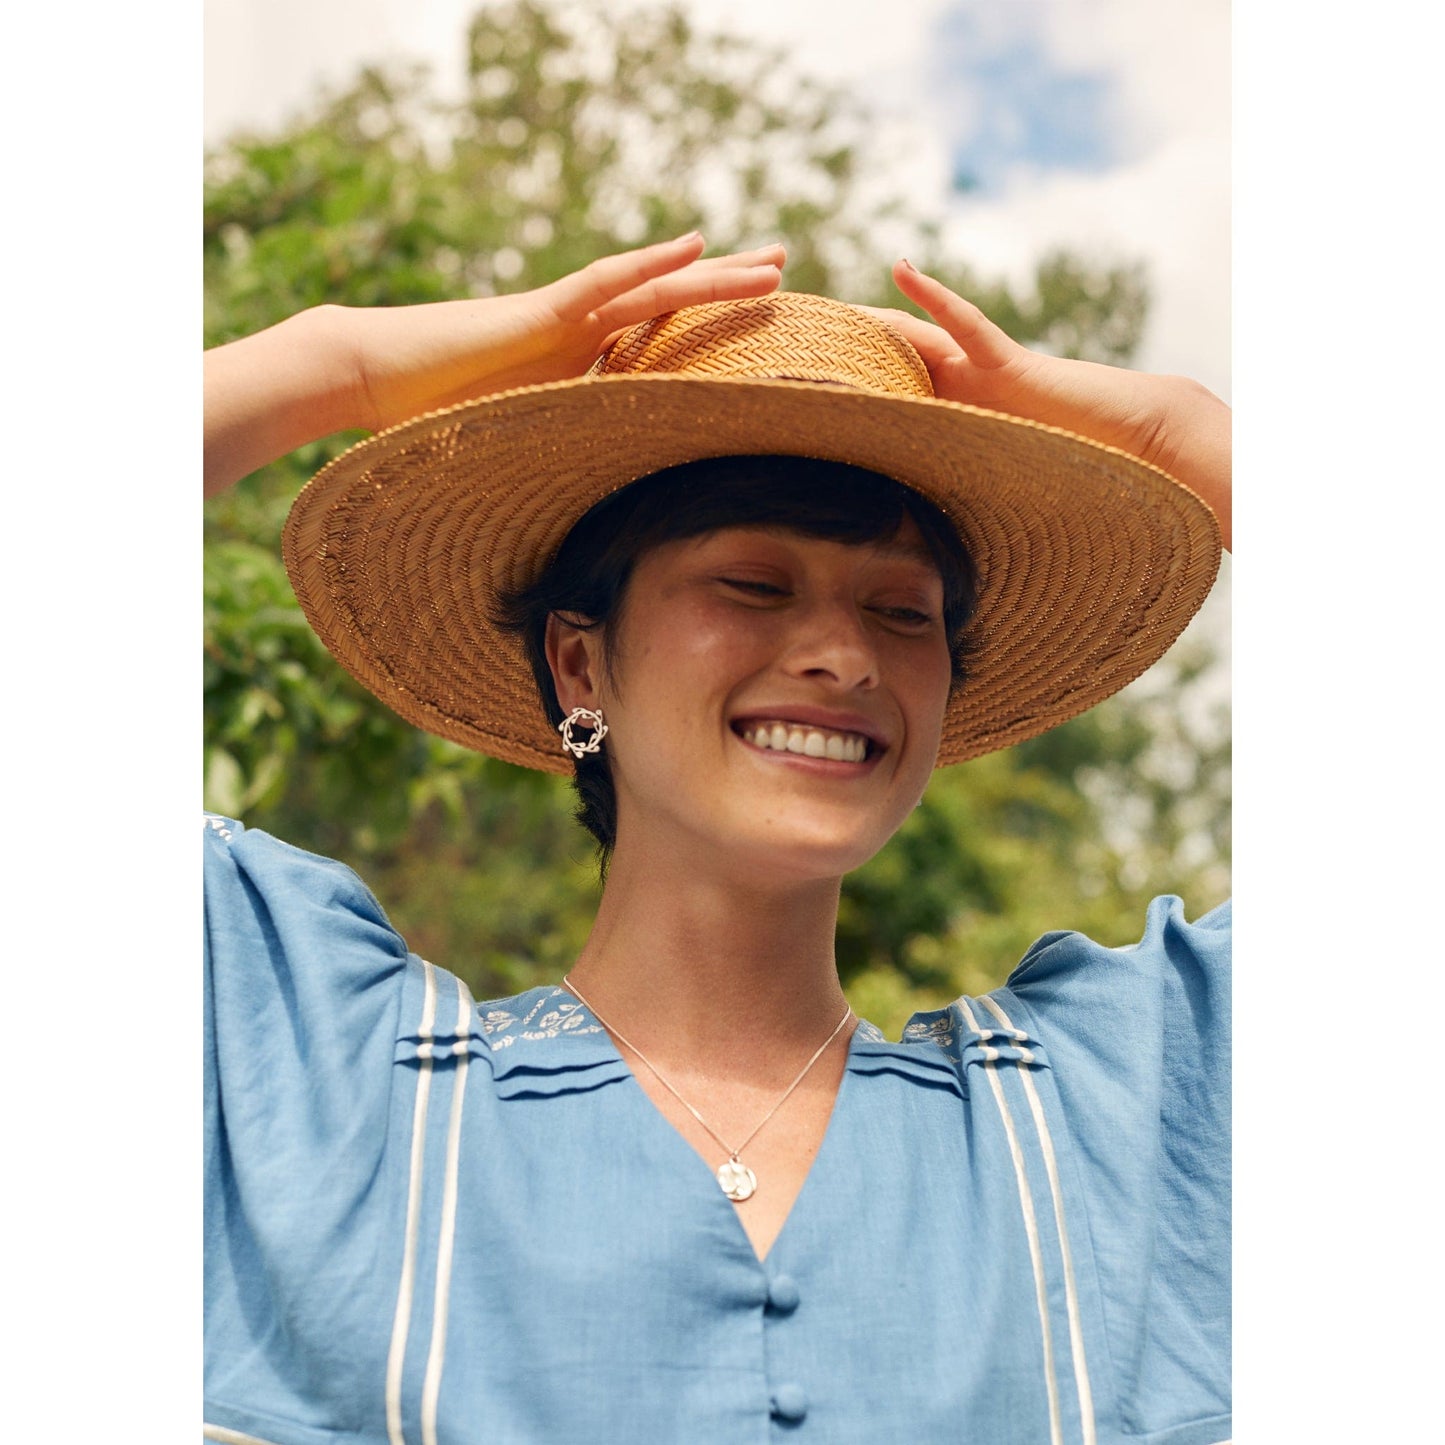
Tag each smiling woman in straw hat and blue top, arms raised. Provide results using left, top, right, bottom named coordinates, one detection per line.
left=207, top=236, right=1228, bottom=1445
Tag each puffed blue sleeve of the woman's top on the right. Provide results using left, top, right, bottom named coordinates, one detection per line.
left=1004, top=897, right=1231, bottom=1445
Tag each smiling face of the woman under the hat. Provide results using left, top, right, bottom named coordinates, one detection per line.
left=580, top=520, right=949, bottom=880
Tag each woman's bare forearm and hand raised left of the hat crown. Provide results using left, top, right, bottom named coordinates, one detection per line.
left=205, top=234, right=783, bottom=496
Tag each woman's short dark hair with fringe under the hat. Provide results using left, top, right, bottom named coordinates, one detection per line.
left=497, top=457, right=978, bottom=867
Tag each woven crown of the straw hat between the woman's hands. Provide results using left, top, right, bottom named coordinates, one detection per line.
left=592, top=292, right=933, bottom=396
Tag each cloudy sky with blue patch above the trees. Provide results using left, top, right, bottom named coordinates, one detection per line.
left=204, top=0, right=1231, bottom=399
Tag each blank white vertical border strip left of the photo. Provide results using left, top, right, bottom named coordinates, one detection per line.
left=0, top=0, right=202, bottom=1445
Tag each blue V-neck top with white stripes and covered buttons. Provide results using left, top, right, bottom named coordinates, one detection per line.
left=197, top=816, right=1230, bottom=1445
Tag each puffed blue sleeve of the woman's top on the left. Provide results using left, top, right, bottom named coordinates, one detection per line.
left=204, top=816, right=419, bottom=1439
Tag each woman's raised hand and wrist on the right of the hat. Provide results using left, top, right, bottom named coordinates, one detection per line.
left=864, top=262, right=1231, bottom=546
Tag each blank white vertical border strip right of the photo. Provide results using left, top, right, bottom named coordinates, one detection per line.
left=1234, top=0, right=1445, bottom=1441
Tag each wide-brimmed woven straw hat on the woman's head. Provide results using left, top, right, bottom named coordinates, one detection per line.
left=283, top=292, right=1220, bottom=773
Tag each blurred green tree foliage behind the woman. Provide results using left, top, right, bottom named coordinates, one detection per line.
left=205, top=0, right=1228, bottom=1035
